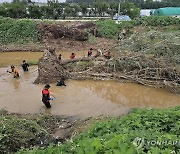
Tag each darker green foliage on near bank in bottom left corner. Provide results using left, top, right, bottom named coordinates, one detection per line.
left=0, top=115, right=50, bottom=153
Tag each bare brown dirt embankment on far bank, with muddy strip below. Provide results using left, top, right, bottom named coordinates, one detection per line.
left=0, top=22, right=116, bottom=52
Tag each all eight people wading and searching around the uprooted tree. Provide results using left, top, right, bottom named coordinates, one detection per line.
left=7, top=48, right=111, bottom=109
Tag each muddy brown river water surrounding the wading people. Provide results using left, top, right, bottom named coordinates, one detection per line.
left=0, top=52, right=180, bottom=117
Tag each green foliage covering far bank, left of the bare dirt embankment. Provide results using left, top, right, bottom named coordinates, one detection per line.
left=0, top=18, right=39, bottom=44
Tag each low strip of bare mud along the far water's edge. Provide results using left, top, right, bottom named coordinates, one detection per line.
left=0, top=37, right=117, bottom=52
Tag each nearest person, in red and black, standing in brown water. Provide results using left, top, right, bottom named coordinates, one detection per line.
left=42, top=84, right=51, bottom=109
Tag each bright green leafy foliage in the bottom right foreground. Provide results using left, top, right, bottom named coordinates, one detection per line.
left=19, top=107, right=180, bottom=154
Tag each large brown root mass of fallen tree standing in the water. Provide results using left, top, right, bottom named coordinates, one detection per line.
left=34, top=49, right=67, bottom=84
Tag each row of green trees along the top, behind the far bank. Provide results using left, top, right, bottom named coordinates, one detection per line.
left=0, top=0, right=140, bottom=19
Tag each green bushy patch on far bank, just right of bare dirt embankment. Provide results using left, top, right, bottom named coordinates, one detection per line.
left=96, top=20, right=120, bottom=38
